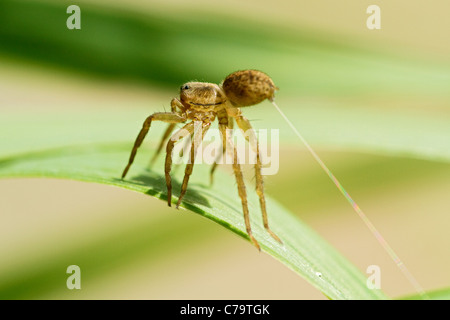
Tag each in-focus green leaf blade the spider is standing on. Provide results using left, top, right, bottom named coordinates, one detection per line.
left=0, top=118, right=386, bottom=299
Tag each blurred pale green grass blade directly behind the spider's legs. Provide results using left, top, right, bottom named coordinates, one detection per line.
left=0, top=97, right=450, bottom=163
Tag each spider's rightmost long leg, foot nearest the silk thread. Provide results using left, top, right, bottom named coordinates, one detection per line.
left=230, top=112, right=283, bottom=243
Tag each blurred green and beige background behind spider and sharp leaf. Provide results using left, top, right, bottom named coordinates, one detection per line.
left=0, top=0, right=450, bottom=299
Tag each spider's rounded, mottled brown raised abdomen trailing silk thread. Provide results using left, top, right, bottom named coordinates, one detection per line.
left=222, top=70, right=278, bottom=107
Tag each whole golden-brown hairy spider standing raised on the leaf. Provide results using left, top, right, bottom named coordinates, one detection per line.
left=122, top=70, right=282, bottom=250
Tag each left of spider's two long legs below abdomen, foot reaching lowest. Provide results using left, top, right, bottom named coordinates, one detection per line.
left=219, top=124, right=261, bottom=251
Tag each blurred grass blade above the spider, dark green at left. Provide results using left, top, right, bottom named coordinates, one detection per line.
left=0, top=0, right=450, bottom=97
